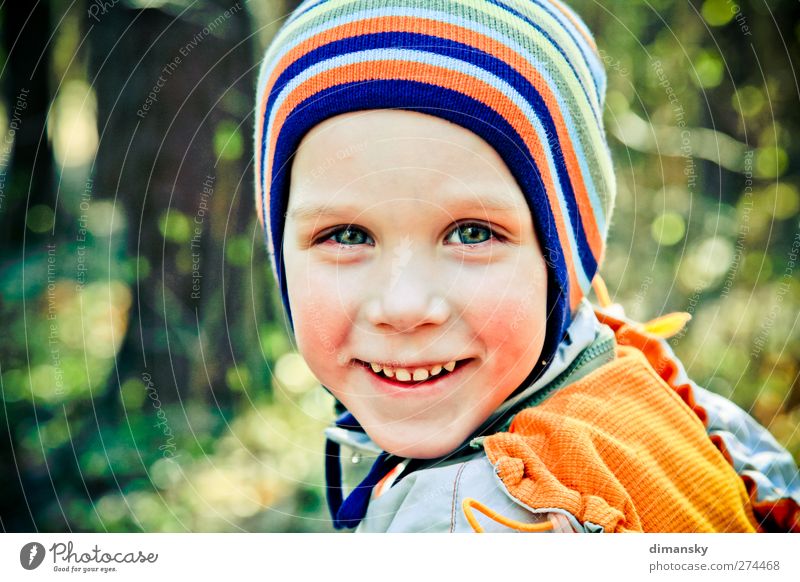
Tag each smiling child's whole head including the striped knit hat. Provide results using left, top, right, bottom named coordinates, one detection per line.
left=256, top=0, right=614, bottom=458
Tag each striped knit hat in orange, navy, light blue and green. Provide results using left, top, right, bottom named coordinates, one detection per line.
left=255, top=0, right=615, bottom=372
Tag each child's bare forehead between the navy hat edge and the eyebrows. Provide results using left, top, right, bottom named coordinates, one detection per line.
left=289, top=110, right=527, bottom=213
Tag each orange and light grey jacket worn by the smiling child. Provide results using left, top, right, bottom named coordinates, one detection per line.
left=327, top=300, right=800, bottom=532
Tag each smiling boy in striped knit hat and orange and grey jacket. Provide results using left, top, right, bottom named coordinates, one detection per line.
left=256, top=0, right=800, bottom=532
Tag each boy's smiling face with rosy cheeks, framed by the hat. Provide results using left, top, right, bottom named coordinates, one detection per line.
left=283, top=110, right=547, bottom=458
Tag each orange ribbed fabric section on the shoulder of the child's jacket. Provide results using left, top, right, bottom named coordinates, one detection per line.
left=484, top=322, right=757, bottom=532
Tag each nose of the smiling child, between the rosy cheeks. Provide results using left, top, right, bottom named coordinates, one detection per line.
left=366, top=263, right=451, bottom=333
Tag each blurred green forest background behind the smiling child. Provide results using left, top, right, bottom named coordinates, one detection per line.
left=0, top=0, right=800, bottom=532
